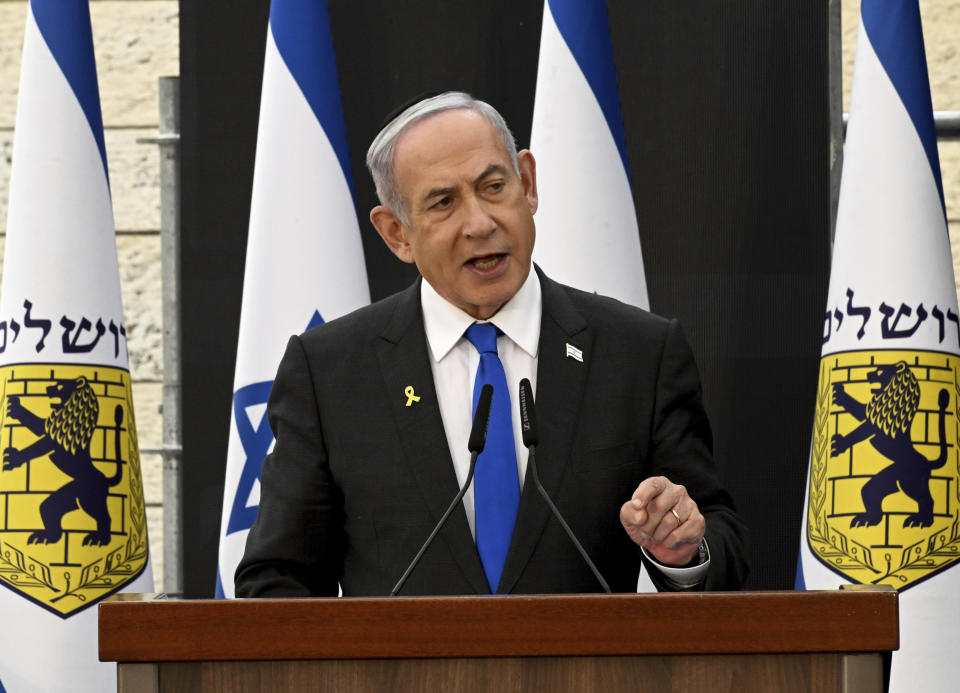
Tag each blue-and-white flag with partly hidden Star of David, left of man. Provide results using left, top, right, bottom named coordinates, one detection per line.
left=216, top=0, right=370, bottom=597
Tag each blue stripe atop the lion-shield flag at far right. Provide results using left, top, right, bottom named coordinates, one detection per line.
left=860, top=0, right=946, bottom=216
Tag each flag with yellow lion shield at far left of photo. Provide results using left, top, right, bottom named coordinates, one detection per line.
left=0, top=0, right=153, bottom=693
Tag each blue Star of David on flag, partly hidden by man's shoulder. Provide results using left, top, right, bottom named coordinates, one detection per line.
left=227, top=310, right=323, bottom=534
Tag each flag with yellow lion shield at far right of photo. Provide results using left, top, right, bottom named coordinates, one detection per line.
left=797, top=0, right=960, bottom=691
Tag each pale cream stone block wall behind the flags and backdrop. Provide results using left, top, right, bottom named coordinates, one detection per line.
left=0, top=0, right=960, bottom=590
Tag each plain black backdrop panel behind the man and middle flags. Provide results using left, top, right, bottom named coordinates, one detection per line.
left=180, top=0, right=829, bottom=597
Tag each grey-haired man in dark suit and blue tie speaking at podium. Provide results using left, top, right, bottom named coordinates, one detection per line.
left=236, top=93, right=746, bottom=597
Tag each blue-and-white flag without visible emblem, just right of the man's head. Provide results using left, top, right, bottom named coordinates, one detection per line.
left=530, top=0, right=649, bottom=308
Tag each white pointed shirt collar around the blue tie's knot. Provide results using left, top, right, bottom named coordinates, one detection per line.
left=420, top=267, right=543, bottom=362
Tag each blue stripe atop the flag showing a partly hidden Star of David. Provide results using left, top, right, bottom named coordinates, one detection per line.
left=270, top=0, right=356, bottom=198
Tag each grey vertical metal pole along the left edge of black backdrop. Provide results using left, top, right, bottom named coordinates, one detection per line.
left=137, top=77, right=183, bottom=596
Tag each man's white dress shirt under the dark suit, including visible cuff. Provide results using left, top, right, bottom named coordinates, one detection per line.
left=420, top=269, right=710, bottom=587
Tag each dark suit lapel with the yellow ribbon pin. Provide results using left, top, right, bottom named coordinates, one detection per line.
left=377, top=281, right=490, bottom=594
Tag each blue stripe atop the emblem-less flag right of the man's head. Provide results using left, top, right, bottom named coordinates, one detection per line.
left=547, top=0, right=630, bottom=172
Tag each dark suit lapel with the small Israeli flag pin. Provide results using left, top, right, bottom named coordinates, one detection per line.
left=498, top=268, right=593, bottom=593
